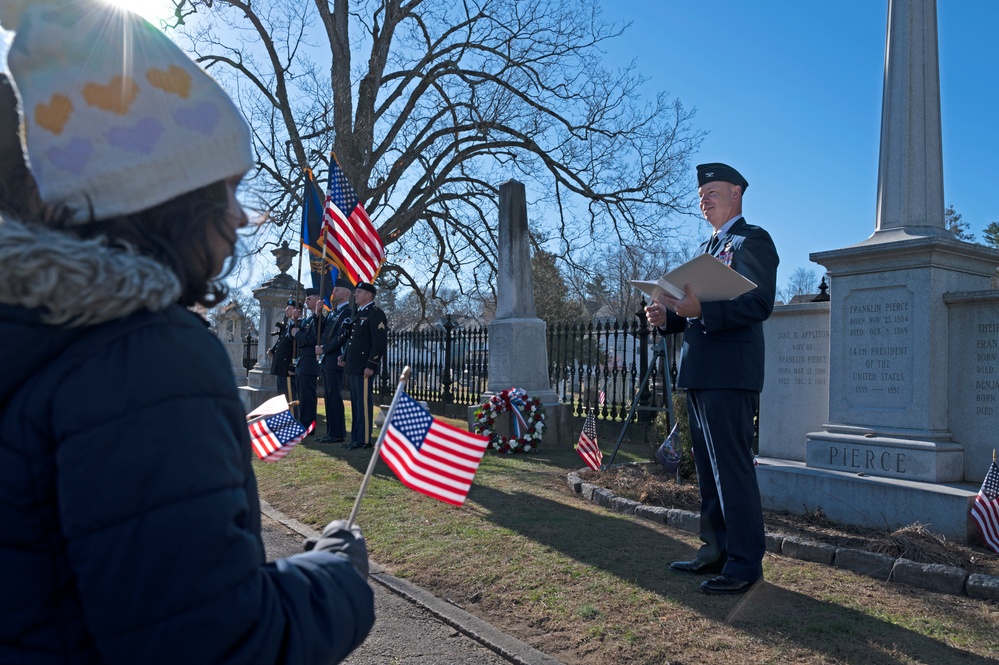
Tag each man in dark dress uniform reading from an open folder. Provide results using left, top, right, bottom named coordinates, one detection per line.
left=645, top=163, right=779, bottom=594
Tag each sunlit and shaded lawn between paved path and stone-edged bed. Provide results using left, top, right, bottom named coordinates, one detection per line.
left=255, top=400, right=999, bottom=665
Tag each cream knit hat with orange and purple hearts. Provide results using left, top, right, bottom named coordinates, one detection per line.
left=0, top=0, right=253, bottom=222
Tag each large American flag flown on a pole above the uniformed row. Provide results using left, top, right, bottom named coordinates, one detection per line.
left=323, top=159, right=385, bottom=284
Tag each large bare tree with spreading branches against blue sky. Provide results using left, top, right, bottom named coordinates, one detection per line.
left=173, top=0, right=701, bottom=300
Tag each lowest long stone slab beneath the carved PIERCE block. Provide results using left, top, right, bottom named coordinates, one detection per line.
left=756, top=457, right=978, bottom=543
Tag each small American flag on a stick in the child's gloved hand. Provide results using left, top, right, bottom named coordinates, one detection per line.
left=381, top=392, right=489, bottom=506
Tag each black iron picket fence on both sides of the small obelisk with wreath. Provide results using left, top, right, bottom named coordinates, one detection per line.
left=377, top=316, right=676, bottom=421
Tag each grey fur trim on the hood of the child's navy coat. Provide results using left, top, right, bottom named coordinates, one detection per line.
left=0, top=219, right=180, bottom=328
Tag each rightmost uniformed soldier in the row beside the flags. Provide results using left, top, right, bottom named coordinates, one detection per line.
left=344, top=282, right=388, bottom=450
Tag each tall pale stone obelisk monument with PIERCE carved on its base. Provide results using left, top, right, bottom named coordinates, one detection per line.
left=759, top=0, right=999, bottom=540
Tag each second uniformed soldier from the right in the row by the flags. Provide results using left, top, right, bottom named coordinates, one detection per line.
left=316, top=277, right=354, bottom=443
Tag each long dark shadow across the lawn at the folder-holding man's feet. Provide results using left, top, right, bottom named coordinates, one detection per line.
left=469, top=485, right=996, bottom=665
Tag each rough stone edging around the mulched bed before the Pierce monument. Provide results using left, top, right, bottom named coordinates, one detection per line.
left=568, top=469, right=999, bottom=602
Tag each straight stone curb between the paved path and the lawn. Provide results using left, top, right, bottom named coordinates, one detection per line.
left=260, top=499, right=563, bottom=665
